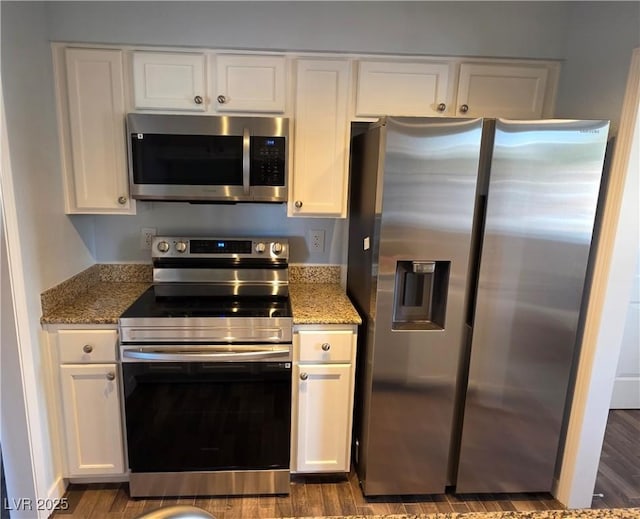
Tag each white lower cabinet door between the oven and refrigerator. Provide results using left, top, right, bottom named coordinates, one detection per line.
left=293, top=364, right=353, bottom=472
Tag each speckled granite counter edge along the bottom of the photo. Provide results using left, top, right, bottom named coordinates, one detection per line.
left=278, top=508, right=640, bottom=519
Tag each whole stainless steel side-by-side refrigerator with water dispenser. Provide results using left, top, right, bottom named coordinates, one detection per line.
left=347, top=117, right=608, bottom=495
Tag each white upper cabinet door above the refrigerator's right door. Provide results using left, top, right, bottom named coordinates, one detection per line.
left=456, top=63, right=548, bottom=119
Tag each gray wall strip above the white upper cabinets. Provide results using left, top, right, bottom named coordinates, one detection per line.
left=48, top=1, right=568, bottom=58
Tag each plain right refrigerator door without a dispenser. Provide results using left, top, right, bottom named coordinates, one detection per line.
left=457, top=120, right=608, bottom=493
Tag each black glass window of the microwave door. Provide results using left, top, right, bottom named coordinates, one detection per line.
left=131, top=133, right=242, bottom=186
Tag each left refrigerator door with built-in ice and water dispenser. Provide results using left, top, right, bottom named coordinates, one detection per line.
left=349, top=117, right=482, bottom=495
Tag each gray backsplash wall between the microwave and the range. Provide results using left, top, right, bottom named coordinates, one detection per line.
left=90, top=202, right=348, bottom=264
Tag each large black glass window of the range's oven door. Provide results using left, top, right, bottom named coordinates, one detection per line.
left=122, top=362, right=291, bottom=472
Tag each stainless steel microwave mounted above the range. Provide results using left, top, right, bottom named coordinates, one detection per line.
left=126, top=114, right=289, bottom=203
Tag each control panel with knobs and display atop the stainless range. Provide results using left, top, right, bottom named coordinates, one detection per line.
left=151, top=236, right=289, bottom=260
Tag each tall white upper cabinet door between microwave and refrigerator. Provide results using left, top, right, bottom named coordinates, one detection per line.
left=289, top=59, right=351, bottom=217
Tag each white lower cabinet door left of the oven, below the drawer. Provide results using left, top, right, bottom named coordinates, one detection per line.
left=60, top=364, right=124, bottom=476
